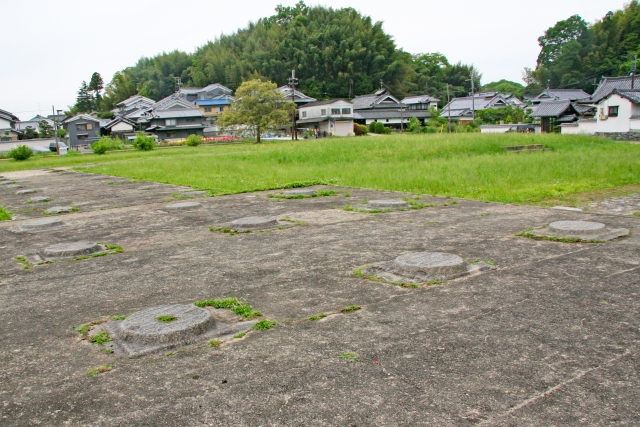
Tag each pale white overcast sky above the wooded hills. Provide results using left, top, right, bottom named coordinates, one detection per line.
left=0, top=0, right=626, bottom=120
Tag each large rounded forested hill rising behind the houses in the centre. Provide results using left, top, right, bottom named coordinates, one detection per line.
left=104, top=2, right=480, bottom=108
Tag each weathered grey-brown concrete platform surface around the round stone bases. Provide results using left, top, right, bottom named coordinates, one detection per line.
left=0, top=171, right=640, bottom=426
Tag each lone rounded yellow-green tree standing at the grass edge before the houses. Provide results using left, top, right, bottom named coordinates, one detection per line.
left=217, top=79, right=296, bottom=143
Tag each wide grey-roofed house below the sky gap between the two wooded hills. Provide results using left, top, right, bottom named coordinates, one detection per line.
left=440, top=92, right=526, bottom=125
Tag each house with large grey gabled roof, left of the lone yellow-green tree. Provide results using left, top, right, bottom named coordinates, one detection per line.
left=141, top=93, right=209, bottom=140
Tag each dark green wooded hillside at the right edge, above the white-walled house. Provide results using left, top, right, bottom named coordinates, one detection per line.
left=525, top=0, right=640, bottom=93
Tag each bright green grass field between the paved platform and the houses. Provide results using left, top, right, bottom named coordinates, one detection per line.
left=0, top=134, right=640, bottom=204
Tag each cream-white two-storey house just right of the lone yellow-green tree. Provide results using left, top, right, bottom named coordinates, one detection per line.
left=297, top=99, right=354, bottom=136
